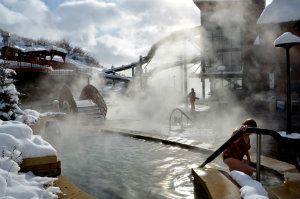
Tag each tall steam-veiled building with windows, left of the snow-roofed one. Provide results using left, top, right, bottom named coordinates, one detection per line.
left=194, top=0, right=265, bottom=97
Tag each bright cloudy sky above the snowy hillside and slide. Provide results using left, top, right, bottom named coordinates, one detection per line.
left=0, top=0, right=200, bottom=67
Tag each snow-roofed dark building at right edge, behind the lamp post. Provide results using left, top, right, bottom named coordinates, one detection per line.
left=254, top=0, right=300, bottom=104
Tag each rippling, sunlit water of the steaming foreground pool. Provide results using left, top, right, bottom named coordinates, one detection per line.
left=44, top=126, right=280, bottom=199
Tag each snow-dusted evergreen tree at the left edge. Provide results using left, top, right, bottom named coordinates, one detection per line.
left=0, top=63, right=23, bottom=121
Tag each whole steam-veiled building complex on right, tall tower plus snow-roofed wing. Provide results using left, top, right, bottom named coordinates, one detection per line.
left=194, top=0, right=300, bottom=112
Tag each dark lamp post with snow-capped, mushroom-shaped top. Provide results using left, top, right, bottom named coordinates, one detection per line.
left=274, top=32, right=300, bottom=134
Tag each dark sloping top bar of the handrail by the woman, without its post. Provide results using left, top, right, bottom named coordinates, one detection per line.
left=199, top=127, right=300, bottom=179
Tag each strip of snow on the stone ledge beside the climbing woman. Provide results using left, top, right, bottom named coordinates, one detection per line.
left=229, top=171, right=269, bottom=199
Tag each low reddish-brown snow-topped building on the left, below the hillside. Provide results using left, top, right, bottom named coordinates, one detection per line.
left=0, top=29, right=129, bottom=105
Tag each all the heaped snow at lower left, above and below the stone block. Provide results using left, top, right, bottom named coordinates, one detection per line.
left=0, top=110, right=60, bottom=199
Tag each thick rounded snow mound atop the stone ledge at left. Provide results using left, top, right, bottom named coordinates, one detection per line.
left=0, top=120, right=56, bottom=158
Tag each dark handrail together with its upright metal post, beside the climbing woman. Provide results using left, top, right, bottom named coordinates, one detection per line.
left=199, top=127, right=300, bottom=181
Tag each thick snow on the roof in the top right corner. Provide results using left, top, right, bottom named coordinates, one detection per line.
left=257, top=0, right=300, bottom=24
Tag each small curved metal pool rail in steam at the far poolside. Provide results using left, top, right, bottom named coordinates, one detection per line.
left=169, top=108, right=193, bottom=131
